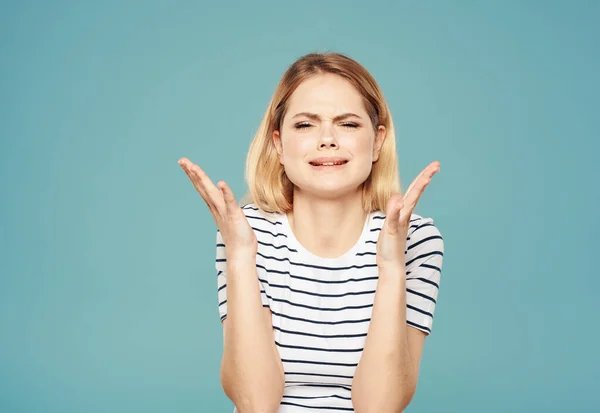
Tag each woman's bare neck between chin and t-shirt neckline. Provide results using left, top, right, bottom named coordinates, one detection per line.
left=288, top=189, right=366, bottom=258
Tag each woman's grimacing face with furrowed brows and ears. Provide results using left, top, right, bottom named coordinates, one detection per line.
left=273, top=74, right=385, bottom=199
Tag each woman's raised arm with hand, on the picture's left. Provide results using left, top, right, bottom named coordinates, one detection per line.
left=179, top=158, right=284, bottom=413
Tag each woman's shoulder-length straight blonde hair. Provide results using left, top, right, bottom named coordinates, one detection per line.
left=241, top=52, right=400, bottom=213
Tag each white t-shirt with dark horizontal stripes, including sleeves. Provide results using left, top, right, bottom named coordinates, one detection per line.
left=216, top=204, right=444, bottom=413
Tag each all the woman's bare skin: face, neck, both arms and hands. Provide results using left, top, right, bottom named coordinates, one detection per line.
left=179, top=75, right=440, bottom=413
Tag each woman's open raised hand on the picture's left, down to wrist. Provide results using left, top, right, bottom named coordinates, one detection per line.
left=178, top=158, right=258, bottom=258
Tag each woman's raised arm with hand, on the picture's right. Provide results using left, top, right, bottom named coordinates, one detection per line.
left=352, top=161, right=443, bottom=413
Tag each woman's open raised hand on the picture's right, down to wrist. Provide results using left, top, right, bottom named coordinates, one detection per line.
left=377, top=161, right=440, bottom=272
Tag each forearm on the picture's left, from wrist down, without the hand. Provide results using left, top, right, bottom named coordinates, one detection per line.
left=221, top=257, right=284, bottom=413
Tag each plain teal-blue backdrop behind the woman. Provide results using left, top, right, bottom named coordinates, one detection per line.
left=0, top=0, right=600, bottom=413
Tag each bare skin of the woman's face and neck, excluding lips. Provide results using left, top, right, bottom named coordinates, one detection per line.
left=273, top=75, right=385, bottom=258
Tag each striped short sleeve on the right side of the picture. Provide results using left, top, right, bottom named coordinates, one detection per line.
left=406, top=215, right=444, bottom=335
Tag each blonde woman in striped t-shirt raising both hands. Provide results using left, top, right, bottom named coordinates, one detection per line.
left=179, top=53, right=443, bottom=413
